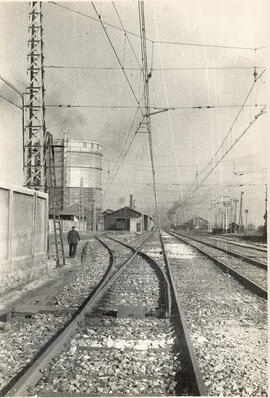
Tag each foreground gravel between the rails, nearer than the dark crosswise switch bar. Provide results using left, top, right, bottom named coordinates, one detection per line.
left=35, top=319, right=181, bottom=395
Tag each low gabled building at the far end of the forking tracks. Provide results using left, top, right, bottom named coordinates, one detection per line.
left=103, top=207, right=154, bottom=232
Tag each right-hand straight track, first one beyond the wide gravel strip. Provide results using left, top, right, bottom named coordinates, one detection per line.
left=168, top=232, right=267, bottom=299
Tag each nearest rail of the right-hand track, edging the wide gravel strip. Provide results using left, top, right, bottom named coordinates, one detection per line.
left=168, top=232, right=267, bottom=299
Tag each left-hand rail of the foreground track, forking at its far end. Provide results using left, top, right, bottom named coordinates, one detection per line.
left=0, top=237, right=152, bottom=397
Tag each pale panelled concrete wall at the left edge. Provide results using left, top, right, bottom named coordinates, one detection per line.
left=0, top=184, right=48, bottom=293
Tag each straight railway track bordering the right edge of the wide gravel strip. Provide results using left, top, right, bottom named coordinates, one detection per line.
left=170, top=232, right=267, bottom=299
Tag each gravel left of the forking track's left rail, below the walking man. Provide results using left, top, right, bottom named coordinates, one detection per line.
left=0, top=236, right=109, bottom=388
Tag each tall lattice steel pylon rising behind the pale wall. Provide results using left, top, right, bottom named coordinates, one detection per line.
left=23, top=1, right=48, bottom=191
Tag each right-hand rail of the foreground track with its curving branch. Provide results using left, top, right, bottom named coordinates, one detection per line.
left=108, top=234, right=208, bottom=396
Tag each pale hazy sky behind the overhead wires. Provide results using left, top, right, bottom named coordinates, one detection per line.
left=0, top=0, right=267, bottom=223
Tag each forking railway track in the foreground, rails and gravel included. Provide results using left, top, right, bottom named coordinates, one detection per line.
left=3, top=232, right=206, bottom=396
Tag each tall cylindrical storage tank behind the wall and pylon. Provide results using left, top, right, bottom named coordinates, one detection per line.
left=64, top=139, right=102, bottom=211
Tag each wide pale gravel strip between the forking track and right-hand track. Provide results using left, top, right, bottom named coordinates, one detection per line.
left=164, top=234, right=267, bottom=396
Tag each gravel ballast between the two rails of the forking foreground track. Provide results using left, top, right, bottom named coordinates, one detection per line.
left=30, top=235, right=188, bottom=395
